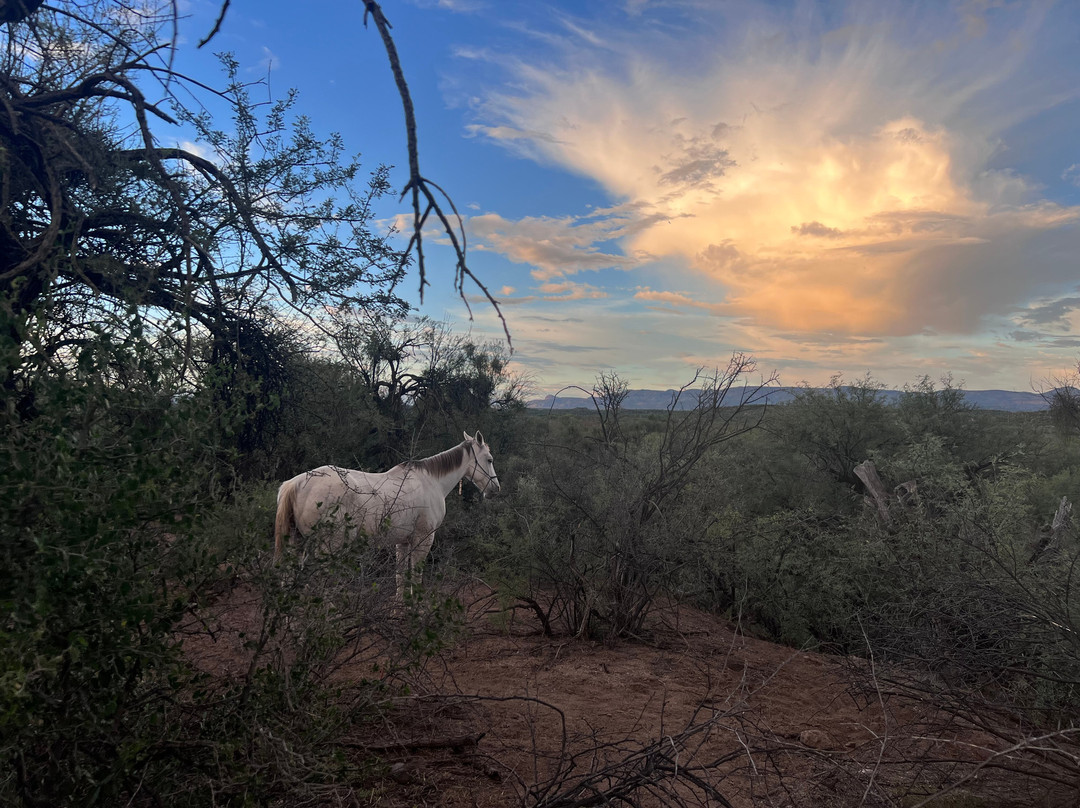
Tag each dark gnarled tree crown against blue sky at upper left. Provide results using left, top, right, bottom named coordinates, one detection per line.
left=0, top=2, right=405, bottom=442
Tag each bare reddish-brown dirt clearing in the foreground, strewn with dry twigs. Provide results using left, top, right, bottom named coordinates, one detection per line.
left=186, top=587, right=1080, bottom=808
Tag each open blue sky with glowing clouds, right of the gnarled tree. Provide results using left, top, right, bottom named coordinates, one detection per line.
left=163, top=0, right=1080, bottom=392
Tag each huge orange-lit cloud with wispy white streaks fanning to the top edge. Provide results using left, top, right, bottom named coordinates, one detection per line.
left=472, top=3, right=1080, bottom=337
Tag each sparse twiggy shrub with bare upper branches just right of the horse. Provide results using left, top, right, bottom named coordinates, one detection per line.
left=494, top=354, right=768, bottom=637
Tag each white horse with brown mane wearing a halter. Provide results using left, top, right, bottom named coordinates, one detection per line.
left=274, top=432, right=499, bottom=598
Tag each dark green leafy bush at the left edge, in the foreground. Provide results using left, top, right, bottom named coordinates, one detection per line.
left=0, top=324, right=229, bottom=804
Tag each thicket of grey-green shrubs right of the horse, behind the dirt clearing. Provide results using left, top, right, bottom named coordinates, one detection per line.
left=486, top=376, right=1080, bottom=764
